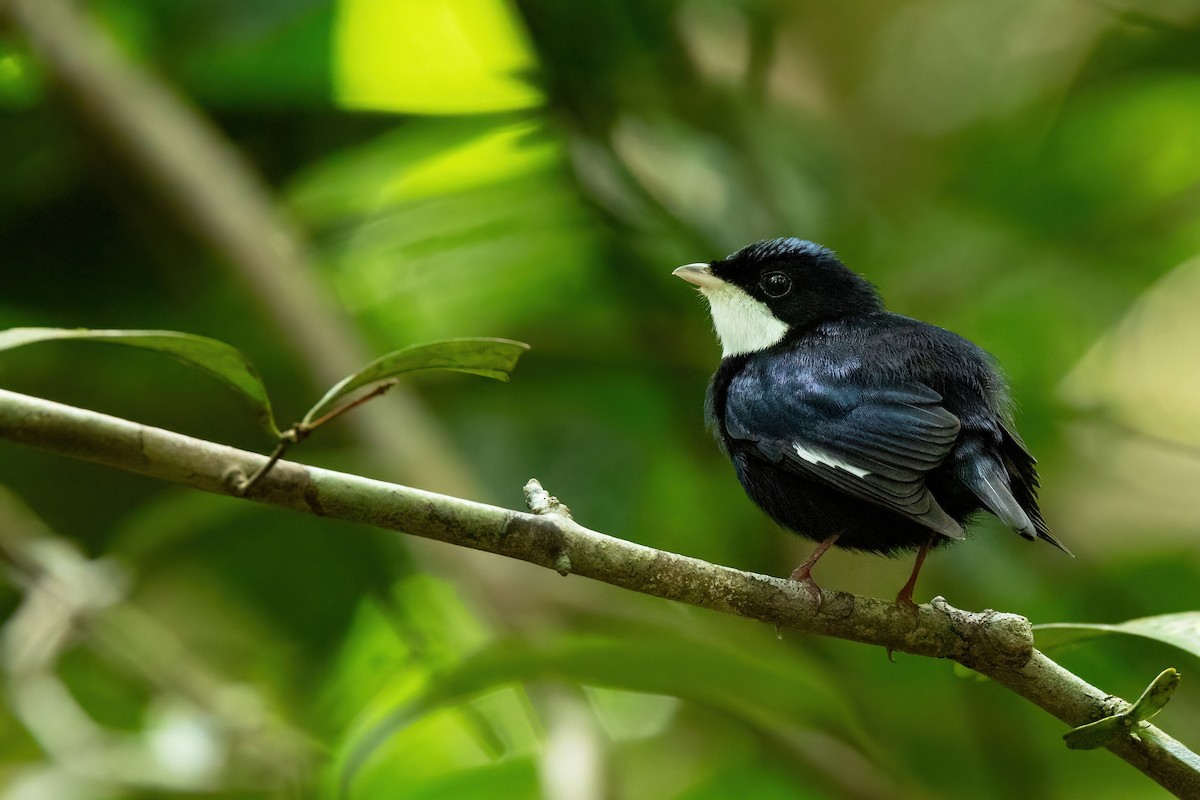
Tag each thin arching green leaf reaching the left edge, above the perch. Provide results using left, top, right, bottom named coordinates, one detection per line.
left=0, top=327, right=280, bottom=438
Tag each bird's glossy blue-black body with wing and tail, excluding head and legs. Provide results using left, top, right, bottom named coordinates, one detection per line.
left=707, top=312, right=1061, bottom=552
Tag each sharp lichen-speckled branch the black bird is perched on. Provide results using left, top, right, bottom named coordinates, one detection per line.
left=0, top=390, right=1200, bottom=798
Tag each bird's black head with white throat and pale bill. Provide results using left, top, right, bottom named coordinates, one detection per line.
left=674, top=239, right=882, bottom=356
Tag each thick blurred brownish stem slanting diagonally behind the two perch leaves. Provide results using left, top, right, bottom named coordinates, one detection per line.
left=0, top=0, right=475, bottom=493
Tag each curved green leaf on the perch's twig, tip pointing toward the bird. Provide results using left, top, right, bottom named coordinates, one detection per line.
left=301, top=338, right=529, bottom=425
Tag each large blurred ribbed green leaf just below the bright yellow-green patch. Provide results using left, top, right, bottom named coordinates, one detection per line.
left=288, top=116, right=600, bottom=350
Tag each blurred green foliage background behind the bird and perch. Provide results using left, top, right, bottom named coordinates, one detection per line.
left=0, top=0, right=1200, bottom=800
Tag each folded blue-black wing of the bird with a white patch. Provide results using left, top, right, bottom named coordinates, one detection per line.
left=725, top=369, right=964, bottom=539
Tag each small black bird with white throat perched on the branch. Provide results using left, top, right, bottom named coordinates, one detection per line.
left=673, top=237, right=1070, bottom=608
